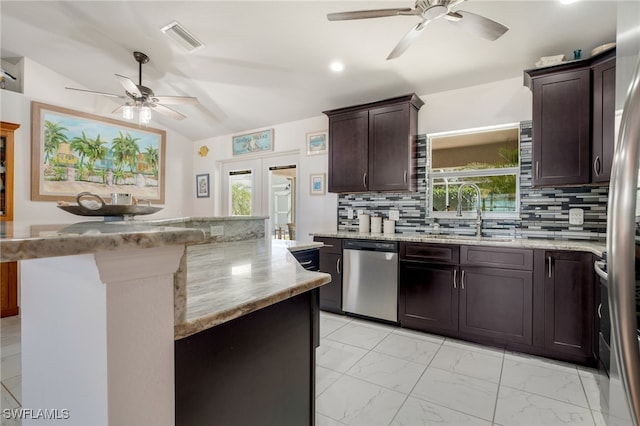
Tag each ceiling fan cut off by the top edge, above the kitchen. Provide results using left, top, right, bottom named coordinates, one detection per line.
left=327, top=0, right=509, bottom=60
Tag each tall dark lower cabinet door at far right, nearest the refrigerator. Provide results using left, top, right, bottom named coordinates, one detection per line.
left=536, top=251, right=594, bottom=360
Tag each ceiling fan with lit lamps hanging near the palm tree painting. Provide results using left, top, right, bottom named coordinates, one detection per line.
left=66, top=52, right=198, bottom=123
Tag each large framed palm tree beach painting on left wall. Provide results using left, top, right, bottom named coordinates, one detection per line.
left=31, top=102, right=166, bottom=204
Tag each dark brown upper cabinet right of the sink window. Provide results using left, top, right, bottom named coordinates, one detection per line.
left=524, top=49, right=615, bottom=186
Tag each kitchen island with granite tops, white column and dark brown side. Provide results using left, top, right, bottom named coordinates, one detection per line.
left=0, top=221, right=329, bottom=425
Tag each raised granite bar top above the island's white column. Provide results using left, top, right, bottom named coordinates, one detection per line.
left=0, top=221, right=205, bottom=262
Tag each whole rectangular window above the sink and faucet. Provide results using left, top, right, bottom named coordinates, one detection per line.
left=427, top=123, right=520, bottom=218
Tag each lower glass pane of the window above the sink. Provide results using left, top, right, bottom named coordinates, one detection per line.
left=432, top=174, right=518, bottom=212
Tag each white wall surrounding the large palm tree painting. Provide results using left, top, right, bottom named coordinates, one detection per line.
left=0, top=58, right=192, bottom=223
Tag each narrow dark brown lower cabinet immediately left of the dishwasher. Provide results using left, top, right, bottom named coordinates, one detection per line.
left=313, top=237, right=343, bottom=314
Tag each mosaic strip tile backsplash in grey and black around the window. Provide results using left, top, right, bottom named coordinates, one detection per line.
left=337, top=121, right=609, bottom=242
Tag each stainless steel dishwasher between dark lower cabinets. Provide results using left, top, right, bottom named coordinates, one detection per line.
left=342, top=240, right=398, bottom=322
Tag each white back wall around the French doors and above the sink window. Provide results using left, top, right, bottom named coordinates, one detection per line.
left=192, top=77, right=532, bottom=241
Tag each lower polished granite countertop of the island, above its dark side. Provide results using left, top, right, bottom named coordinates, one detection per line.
left=175, top=239, right=331, bottom=340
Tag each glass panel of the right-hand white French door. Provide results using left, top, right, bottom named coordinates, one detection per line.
left=269, top=165, right=296, bottom=240
